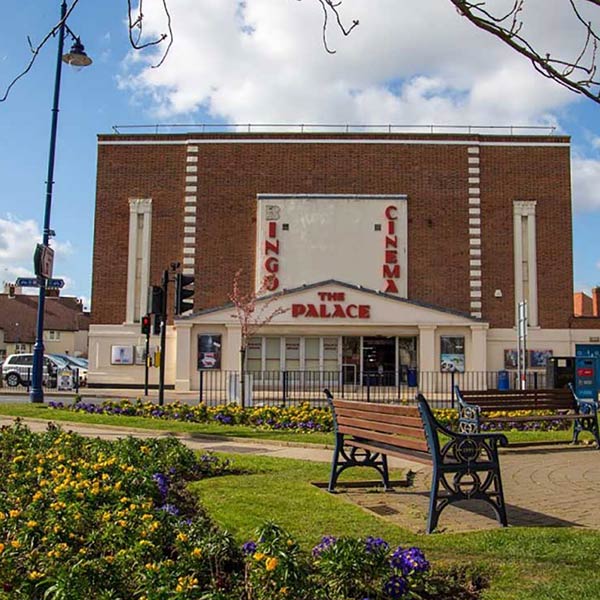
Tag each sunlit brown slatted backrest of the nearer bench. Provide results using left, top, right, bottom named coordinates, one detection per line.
left=331, top=398, right=428, bottom=453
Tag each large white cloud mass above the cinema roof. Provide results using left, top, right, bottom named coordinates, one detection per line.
left=120, top=0, right=577, bottom=125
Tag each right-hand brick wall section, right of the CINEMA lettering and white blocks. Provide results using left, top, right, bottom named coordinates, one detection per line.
left=480, top=146, right=573, bottom=329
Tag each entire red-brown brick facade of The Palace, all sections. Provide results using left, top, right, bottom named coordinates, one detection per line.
left=92, top=134, right=572, bottom=327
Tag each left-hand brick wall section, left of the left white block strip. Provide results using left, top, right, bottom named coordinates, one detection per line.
left=92, top=145, right=185, bottom=323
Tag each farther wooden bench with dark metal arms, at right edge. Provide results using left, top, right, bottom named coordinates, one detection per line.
left=455, top=385, right=600, bottom=448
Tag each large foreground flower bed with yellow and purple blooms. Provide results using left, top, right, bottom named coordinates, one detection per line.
left=0, top=423, right=485, bottom=600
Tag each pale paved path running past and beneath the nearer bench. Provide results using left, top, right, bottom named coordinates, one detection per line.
left=0, top=417, right=600, bottom=532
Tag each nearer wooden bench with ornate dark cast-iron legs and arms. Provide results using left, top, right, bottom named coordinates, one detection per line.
left=324, top=390, right=508, bottom=533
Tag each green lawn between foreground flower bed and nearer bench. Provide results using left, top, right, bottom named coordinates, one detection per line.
left=193, top=455, right=600, bottom=600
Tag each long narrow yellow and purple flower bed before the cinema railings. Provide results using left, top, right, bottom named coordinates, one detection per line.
left=48, top=399, right=570, bottom=433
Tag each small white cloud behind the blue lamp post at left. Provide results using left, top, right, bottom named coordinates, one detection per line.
left=0, top=214, right=73, bottom=288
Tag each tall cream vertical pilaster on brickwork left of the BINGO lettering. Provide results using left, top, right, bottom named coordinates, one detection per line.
left=125, top=198, right=152, bottom=323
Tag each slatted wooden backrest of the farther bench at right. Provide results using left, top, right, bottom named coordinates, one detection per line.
left=458, top=388, right=577, bottom=412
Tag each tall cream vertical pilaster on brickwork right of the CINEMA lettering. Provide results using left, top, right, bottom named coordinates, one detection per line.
left=513, top=200, right=538, bottom=327
